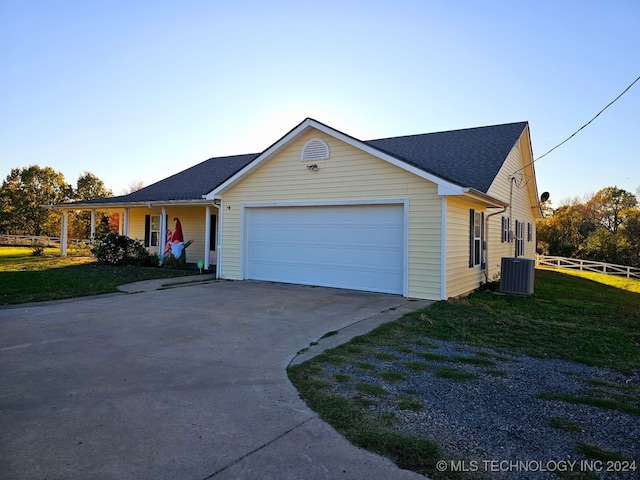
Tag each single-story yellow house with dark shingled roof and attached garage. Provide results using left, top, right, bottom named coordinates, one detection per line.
left=58, top=118, right=541, bottom=300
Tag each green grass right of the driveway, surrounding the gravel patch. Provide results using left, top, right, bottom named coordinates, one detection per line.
left=288, top=270, right=640, bottom=479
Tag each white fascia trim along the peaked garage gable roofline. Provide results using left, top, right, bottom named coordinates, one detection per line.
left=207, top=118, right=465, bottom=199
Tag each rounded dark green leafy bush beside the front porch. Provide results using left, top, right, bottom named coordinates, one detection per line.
left=91, top=233, right=158, bottom=267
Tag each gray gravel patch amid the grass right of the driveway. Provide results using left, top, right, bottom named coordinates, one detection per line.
left=325, top=340, right=640, bottom=479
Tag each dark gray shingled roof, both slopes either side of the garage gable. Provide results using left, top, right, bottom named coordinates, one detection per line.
left=72, top=122, right=527, bottom=204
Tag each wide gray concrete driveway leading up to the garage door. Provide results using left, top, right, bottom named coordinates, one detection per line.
left=0, top=282, right=427, bottom=480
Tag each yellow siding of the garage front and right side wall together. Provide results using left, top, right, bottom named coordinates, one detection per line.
left=221, top=125, right=537, bottom=299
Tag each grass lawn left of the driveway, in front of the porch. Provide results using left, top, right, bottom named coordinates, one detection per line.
left=0, top=247, right=197, bottom=305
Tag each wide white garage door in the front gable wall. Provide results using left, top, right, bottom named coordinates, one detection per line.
left=245, top=204, right=405, bottom=294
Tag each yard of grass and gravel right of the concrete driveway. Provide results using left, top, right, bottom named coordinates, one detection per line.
left=289, top=270, right=640, bottom=479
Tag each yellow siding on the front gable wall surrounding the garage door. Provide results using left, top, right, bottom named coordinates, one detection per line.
left=222, top=127, right=441, bottom=299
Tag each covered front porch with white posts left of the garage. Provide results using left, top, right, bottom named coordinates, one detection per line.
left=54, top=199, right=221, bottom=270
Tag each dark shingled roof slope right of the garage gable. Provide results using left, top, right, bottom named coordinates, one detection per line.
left=364, top=122, right=527, bottom=193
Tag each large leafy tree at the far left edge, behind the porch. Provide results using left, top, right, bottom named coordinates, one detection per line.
left=0, top=165, right=73, bottom=236
